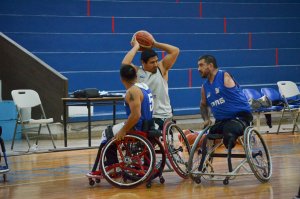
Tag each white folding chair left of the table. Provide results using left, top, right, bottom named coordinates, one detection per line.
left=11, top=89, right=56, bottom=151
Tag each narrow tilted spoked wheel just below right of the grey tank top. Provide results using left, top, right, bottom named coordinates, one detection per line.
left=163, top=121, right=190, bottom=178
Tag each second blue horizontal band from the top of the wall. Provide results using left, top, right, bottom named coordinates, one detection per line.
left=0, top=15, right=300, bottom=34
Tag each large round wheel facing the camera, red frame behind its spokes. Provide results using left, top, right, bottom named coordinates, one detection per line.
left=100, top=134, right=155, bottom=188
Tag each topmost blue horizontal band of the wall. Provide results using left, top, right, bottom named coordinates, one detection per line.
left=0, top=0, right=300, bottom=17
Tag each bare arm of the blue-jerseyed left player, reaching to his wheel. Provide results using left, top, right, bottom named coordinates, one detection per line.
left=115, top=86, right=144, bottom=140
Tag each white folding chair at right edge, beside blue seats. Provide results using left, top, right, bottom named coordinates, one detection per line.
left=277, top=81, right=300, bottom=133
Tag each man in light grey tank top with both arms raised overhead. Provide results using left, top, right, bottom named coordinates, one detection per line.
left=122, top=33, right=179, bottom=129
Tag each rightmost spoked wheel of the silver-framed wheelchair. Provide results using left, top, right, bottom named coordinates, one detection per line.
left=244, top=127, right=272, bottom=182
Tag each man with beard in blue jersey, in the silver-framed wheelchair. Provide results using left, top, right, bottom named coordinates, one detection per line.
left=198, top=55, right=253, bottom=148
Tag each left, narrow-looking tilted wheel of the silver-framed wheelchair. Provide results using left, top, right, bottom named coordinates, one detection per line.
left=188, top=127, right=208, bottom=176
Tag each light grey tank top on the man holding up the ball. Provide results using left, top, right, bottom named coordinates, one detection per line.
left=137, top=67, right=172, bottom=118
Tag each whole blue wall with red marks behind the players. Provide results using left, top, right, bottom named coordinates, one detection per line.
left=0, top=0, right=300, bottom=119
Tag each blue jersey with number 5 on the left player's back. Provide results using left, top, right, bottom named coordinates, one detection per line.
left=125, top=83, right=153, bottom=130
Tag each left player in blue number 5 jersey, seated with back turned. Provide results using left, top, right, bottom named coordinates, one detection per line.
left=87, top=65, right=154, bottom=177
